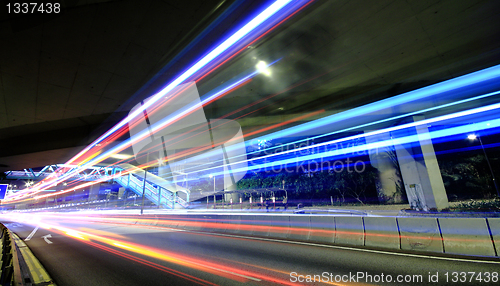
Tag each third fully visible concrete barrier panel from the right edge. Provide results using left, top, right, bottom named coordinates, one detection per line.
left=363, top=217, right=401, bottom=249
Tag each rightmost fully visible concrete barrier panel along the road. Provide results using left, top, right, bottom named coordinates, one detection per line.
left=438, top=218, right=495, bottom=256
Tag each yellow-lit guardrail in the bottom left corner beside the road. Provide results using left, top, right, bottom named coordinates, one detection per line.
left=0, top=223, right=55, bottom=286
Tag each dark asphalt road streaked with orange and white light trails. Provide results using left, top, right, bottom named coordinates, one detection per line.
left=0, top=217, right=500, bottom=286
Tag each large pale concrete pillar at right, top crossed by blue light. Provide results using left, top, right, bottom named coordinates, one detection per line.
left=391, top=116, right=449, bottom=210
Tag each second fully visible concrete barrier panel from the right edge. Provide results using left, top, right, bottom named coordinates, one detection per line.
left=397, top=217, right=444, bottom=253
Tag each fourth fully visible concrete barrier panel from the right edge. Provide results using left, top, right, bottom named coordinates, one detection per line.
left=334, top=216, right=365, bottom=245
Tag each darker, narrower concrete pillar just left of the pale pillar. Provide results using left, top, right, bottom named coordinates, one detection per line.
left=366, top=131, right=403, bottom=204
